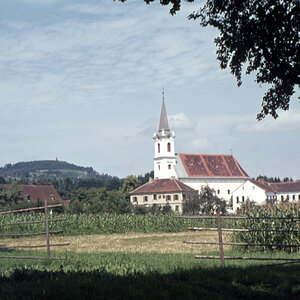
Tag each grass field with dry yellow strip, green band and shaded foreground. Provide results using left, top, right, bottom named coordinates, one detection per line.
left=0, top=232, right=300, bottom=299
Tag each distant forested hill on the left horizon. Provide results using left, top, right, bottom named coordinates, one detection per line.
left=0, top=160, right=101, bottom=180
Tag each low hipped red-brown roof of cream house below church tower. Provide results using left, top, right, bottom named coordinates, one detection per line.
left=130, top=179, right=197, bottom=195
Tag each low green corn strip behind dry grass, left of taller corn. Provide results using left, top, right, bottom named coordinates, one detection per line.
left=0, top=213, right=220, bottom=236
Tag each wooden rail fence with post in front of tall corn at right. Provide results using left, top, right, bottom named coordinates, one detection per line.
left=175, top=212, right=300, bottom=267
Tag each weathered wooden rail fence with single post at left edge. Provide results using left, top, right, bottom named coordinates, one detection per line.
left=0, top=200, right=70, bottom=260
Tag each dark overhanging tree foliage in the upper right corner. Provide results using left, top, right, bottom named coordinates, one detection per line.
left=120, top=0, right=300, bottom=120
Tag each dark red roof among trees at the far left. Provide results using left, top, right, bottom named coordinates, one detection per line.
left=3, top=184, right=63, bottom=203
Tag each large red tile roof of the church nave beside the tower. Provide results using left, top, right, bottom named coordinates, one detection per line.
left=179, top=153, right=249, bottom=177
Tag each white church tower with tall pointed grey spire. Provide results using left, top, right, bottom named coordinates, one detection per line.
left=153, top=92, right=176, bottom=179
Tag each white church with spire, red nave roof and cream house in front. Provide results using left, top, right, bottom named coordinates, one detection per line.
left=130, top=94, right=250, bottom=213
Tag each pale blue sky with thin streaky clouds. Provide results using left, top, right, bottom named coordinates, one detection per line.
left=0, top=0, right=300, bottom=179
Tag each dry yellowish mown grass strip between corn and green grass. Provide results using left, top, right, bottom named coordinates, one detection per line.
left=1, top=232, right=229, bottom=254
